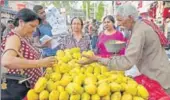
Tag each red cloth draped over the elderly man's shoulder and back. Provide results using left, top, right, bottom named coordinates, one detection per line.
left=142, top=19, right=168, bottom=46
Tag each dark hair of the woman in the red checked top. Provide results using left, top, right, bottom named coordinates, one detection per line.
left=14, top=8, right=41, bottom=26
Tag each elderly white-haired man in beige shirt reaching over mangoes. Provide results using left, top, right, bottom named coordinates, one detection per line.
left=80, top=4, right=170, bottom=93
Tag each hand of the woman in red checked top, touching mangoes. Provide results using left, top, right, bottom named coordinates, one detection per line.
left=38, top=56, right=56, bottom=67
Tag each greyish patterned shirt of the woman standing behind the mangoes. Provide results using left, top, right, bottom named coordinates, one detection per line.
left=60, top=34, right=90, bottom=51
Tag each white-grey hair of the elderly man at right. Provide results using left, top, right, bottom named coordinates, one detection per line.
left=116, top=3, right=139, bottom=21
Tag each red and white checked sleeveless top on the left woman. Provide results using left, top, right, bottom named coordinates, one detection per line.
left=1, top=32, right=42, bottom=87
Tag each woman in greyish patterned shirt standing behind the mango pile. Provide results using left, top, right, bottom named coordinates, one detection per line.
left=60, top=17, right=90, bottom=51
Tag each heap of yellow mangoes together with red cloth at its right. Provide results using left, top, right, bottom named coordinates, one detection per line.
left=27, top=48, right=169, bottom=100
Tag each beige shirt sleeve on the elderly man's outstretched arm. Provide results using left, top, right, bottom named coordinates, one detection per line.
left=98, top=30, right=145, bottom=70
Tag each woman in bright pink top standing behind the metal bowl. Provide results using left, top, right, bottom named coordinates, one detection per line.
left=97, top=15, right=126, bottom=57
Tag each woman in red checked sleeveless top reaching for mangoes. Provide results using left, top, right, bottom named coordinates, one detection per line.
left=1, top=8, right=55, bottom=100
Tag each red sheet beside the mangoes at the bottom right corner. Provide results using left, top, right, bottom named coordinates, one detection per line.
left=134, top=74, right=170, bottom=100
